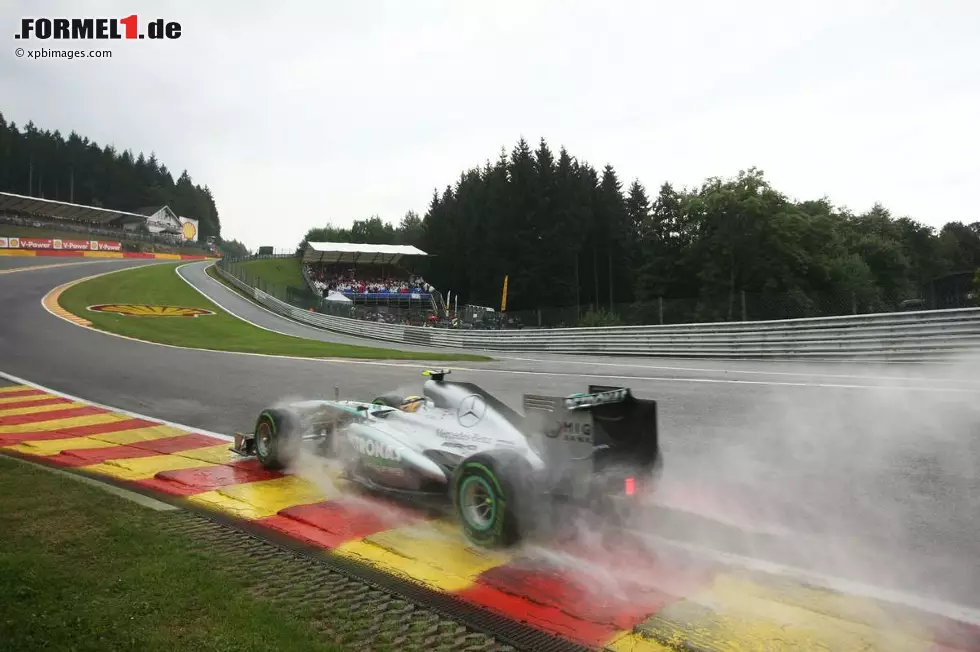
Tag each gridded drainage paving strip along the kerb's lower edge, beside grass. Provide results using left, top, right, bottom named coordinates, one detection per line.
left=172, top=505, right=594, bottom=652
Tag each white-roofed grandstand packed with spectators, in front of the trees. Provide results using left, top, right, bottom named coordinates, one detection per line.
left=303, top=242, right=446, bottom=322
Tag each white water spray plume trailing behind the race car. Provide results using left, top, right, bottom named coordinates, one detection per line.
left=578, top=355, right=980, bottom=630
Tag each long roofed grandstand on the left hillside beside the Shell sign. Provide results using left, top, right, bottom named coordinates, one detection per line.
left=0, top=192, right=214, bottom=253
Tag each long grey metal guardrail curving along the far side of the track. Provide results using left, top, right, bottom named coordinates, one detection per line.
left=216, top=266, right=980, bottom=361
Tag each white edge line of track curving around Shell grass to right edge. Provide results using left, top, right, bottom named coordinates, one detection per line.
left=34, top=261, right=980, bottom=394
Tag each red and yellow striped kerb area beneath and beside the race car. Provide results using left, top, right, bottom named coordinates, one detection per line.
left=0, top=264, right=980, bottom=652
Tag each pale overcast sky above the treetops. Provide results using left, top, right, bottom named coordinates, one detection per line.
left=0, top=0, right=980, bottom=248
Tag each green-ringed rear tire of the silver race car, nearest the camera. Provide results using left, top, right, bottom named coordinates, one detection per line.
left=450, top=450, right=531, bottom=548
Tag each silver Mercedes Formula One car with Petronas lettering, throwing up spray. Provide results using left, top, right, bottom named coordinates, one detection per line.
left=232, top=370, right=661, bottom=547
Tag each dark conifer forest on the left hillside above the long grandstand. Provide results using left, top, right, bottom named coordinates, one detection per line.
left=0, top=114, right=221, bottom=241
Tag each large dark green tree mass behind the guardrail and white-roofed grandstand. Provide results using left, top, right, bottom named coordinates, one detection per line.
left=300, top=139, right=980, bottom=323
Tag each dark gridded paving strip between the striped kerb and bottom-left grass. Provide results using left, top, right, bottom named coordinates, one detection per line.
left=167, top=511, right=589, bottom=652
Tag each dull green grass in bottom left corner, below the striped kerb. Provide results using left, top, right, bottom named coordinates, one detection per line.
left=0, top=457, right=343, bottom=652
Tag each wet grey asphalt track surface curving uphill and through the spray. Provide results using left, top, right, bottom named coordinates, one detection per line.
left=0, top=258, right=980, bottom=608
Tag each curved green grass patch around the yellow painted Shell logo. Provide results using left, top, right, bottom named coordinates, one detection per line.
left=59, top=263, right=491, bottom=361
